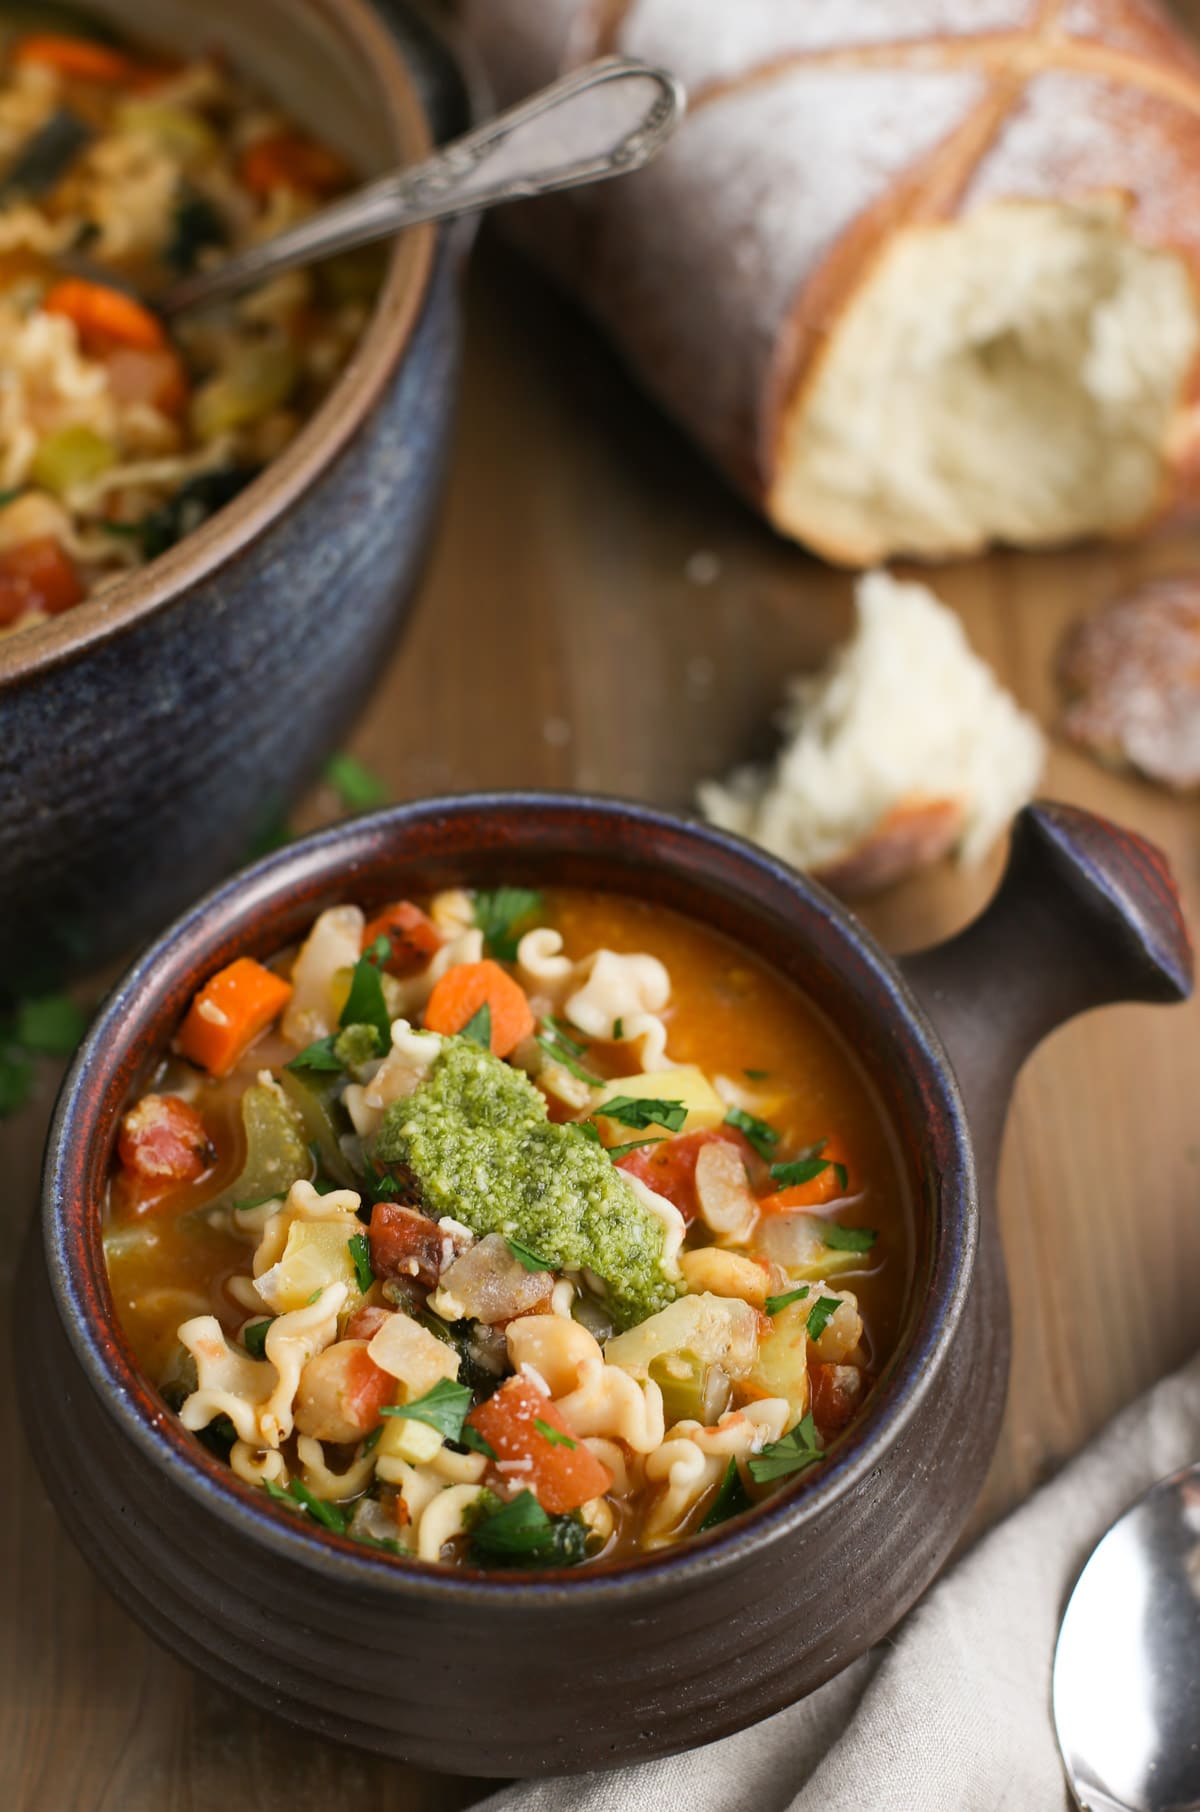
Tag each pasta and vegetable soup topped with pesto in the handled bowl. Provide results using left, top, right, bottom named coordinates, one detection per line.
left=107, top=888, right=910, bottom=1567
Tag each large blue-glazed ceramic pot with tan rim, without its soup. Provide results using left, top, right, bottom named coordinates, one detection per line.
left=0, top=0, right=468, bottom=993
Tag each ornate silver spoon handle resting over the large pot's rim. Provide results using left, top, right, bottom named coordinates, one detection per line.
left=158, top=56, right=687, bottom=315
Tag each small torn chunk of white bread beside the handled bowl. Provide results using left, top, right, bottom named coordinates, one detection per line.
left=700, top=573, right=1044, bottom=897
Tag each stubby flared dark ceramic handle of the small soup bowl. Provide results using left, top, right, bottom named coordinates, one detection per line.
left=901, top=801, right=1193, bottom=1176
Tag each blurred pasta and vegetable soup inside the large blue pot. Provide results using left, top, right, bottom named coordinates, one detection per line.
left=0, top=9, right=382, bottom=632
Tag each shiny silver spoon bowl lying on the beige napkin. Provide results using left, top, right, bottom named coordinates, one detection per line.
left=1053, top=1466, right=1200, bottom=1812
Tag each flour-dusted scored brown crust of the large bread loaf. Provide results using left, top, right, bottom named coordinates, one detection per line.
left=466, top=0, right=1200, bottom=565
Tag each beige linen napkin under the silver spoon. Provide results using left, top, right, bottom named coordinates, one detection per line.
left=477, top=1359, right=1200, bottom=1812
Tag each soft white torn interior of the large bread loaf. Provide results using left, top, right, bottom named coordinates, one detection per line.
left=769, top=201, right=1200, bottom=564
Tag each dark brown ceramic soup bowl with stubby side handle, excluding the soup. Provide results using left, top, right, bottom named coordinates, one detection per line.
left=16, top=794, right=1191, bottom=1774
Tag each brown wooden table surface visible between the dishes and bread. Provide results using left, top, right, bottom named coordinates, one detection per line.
left=0, top=246, right=1200, bottom=1812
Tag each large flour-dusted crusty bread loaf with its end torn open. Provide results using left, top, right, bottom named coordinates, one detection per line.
left=464, top=0, right=1200, bottom=565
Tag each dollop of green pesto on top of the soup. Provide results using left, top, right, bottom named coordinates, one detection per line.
left=373, top=1038, right=676, bottom=1328
